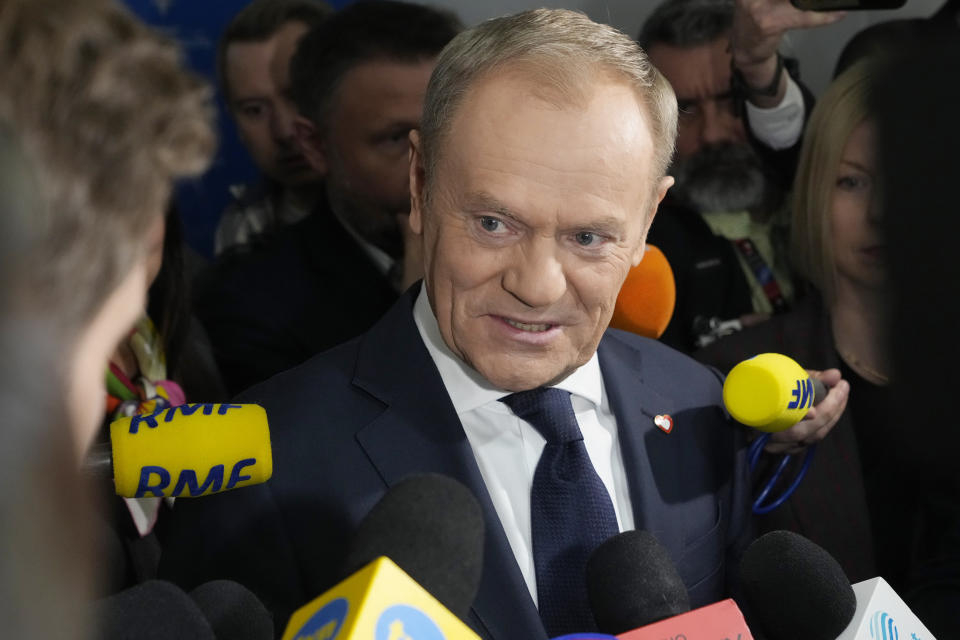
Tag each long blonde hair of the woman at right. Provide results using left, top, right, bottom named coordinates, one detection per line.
left=791, top=61, right=874, bottom=302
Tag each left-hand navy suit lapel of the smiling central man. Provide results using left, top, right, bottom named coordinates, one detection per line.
left=353, top=287, right=546, bottom=640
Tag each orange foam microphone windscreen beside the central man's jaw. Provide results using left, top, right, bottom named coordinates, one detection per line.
left=610, top=244, right=677, bottom=339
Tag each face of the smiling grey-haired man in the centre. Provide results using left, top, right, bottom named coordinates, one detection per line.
left=410, top=72, right=671, bottom=391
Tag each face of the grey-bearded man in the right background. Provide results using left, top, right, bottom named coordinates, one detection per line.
left=649, top=37, right=768, bottom=213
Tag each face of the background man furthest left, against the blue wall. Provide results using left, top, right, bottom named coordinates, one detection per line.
left=225, top=22, right=319, bottom=186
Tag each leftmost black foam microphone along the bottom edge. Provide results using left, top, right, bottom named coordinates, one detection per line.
left=94, top=580, right=217, bottom=640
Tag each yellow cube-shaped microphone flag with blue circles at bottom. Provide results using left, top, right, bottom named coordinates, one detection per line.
left=282, top=556, right=480, bottom=640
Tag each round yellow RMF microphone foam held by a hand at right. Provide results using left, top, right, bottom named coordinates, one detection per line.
left=723, top=353, right=826, bottom=433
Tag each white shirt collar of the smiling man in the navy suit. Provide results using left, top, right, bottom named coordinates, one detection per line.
left=413, top=283, right=603, bottom=415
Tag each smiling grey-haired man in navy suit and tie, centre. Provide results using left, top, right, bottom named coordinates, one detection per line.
left=162, top=10, right=750, bottom=640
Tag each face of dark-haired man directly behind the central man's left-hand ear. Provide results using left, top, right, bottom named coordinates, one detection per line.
left=320, top=59, right=436, bottom=258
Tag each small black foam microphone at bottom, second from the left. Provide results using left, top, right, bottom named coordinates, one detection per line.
left=190, top=580, right=274, bottom=640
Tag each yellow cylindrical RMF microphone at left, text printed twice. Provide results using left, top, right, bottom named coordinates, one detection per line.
left=84, top=404, right=273, bottom=498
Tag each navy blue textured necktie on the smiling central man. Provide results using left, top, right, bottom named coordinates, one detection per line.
left=501, top=388, right=619, bottom=637
